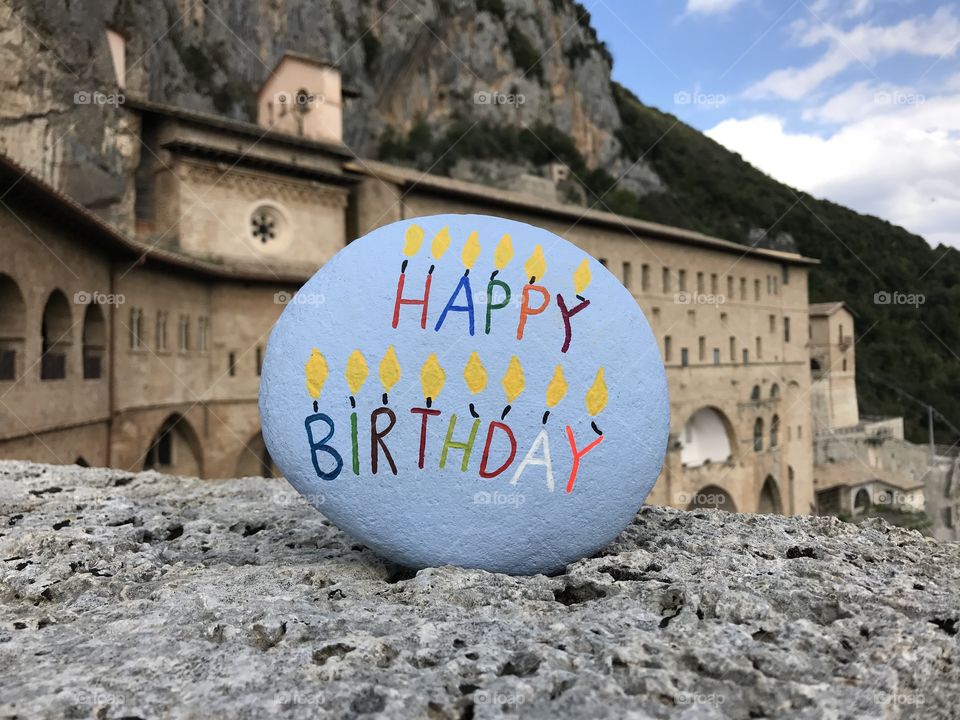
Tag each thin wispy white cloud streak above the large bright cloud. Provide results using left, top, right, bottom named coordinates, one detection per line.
left=746, top=7, right=960, bottom=100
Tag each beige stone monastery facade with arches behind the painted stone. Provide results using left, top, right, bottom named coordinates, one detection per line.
left=0, top=56, right=815, bottom=514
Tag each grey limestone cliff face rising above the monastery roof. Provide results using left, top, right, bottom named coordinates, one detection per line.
left=0, top=0, right=644, bottom=225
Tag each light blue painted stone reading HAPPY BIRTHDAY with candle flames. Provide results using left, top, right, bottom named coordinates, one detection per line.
left=260, top=215, right=670, bottom=574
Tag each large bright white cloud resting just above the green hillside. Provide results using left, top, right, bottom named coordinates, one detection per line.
left=707, top=89, right=960, bottom=247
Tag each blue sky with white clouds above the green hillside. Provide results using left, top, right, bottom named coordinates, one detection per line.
left=583, top=0, right=960, bottom=247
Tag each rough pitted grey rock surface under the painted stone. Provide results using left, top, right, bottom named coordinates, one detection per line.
left=0, top=462, right=960, bottom=720
